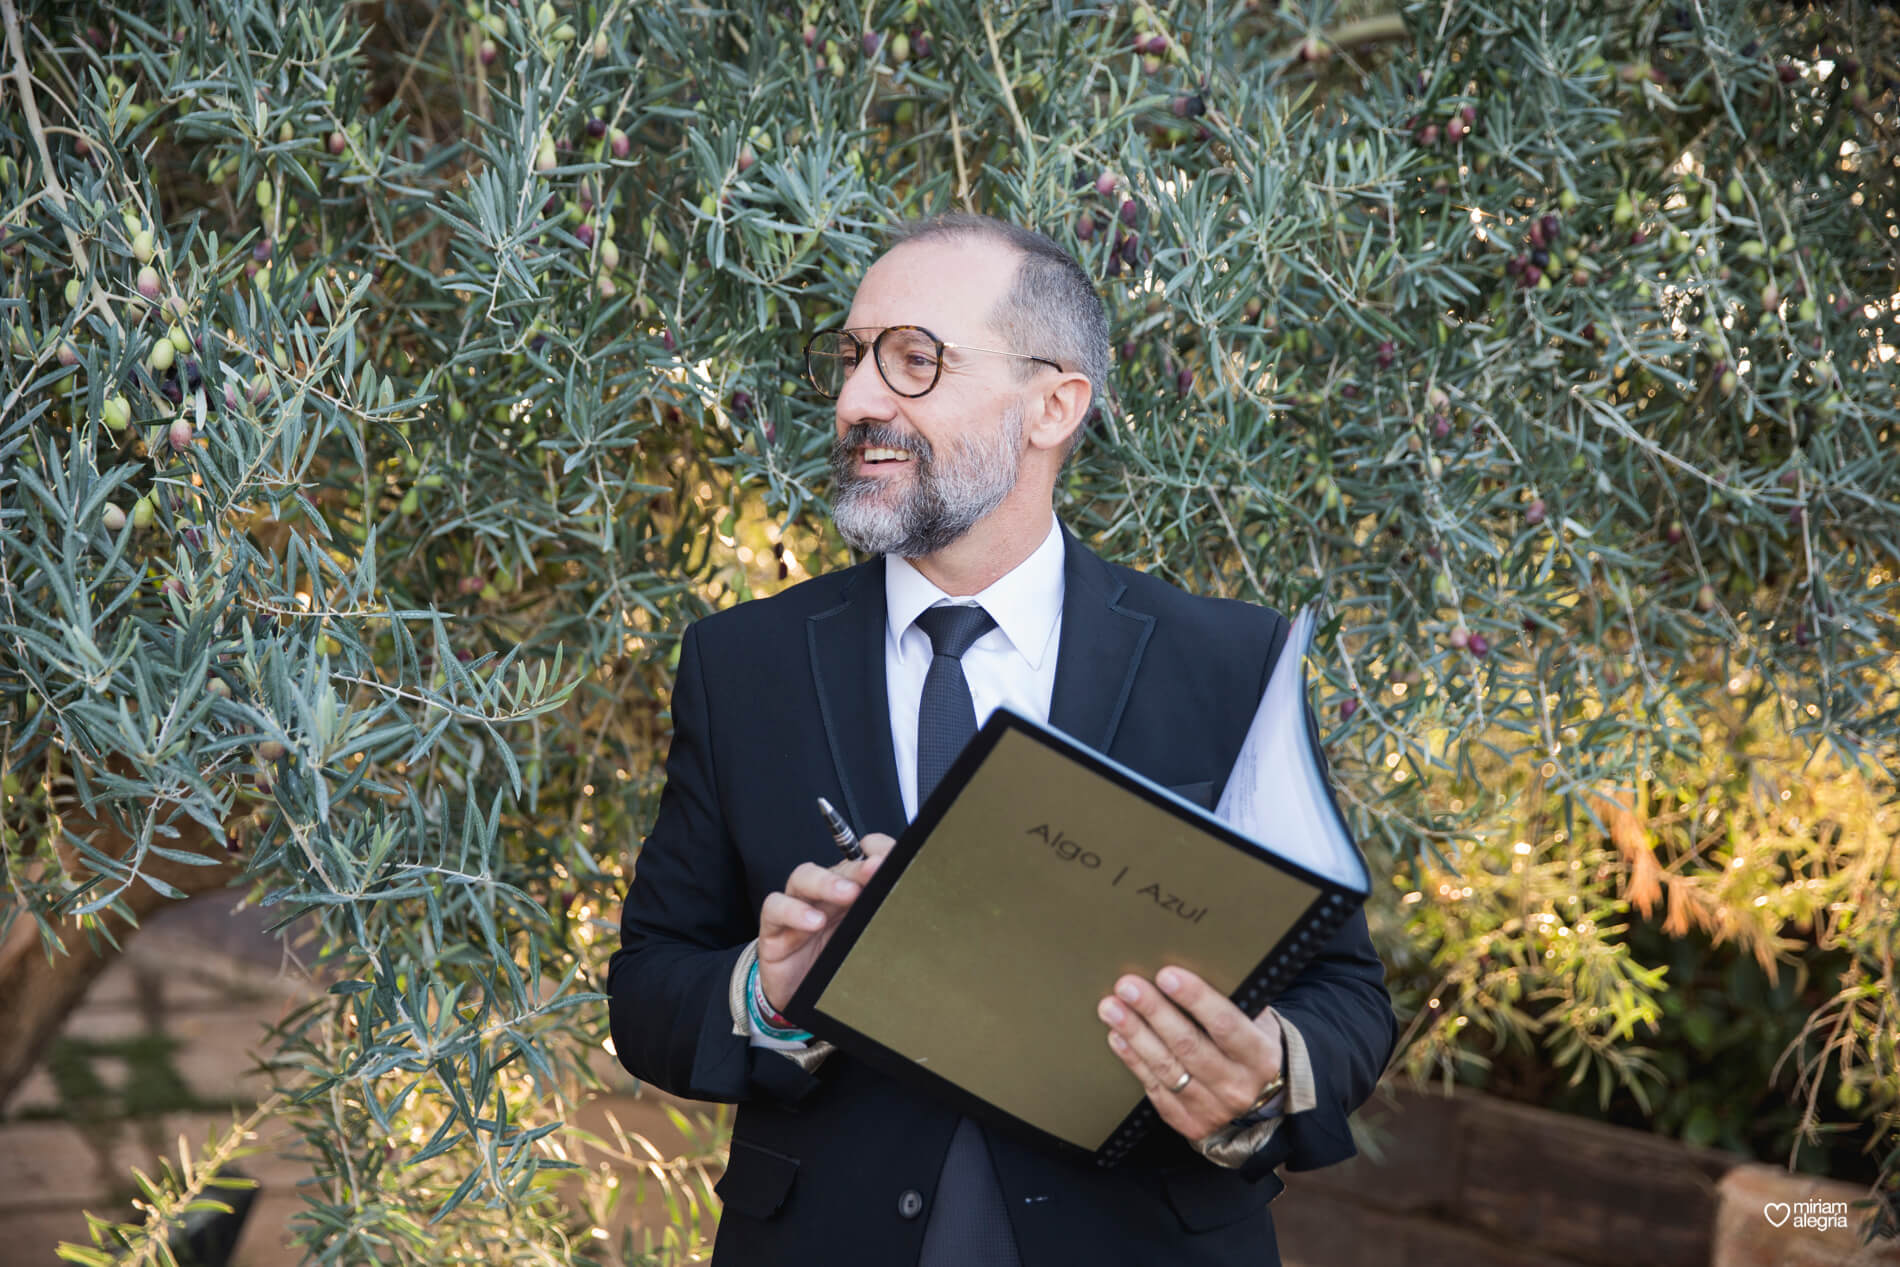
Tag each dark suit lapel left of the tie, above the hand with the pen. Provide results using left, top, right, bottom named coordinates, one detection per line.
left=806, top=557, right=904, bottom=836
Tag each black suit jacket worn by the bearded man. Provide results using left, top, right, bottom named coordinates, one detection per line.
left=608, top=528, right=1397, bottom=1267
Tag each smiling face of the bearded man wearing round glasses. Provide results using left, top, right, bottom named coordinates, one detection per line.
left=832, top=239, right=1024, bottom=558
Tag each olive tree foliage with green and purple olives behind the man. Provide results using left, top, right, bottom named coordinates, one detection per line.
left=0, top=0, right=1900, bottom=1261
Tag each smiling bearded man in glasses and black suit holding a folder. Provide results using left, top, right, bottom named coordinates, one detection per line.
left=608, top=217, right=1397, bottom=1267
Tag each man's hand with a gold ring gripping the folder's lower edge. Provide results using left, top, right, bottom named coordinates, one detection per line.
left=1096, top=965, right=1281, bottom=1140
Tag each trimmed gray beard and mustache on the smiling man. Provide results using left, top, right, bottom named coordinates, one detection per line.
left=830, top=405, right=1022, bottom=558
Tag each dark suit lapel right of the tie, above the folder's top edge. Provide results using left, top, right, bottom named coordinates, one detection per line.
left=1049, top=524, right=1155, bottom=752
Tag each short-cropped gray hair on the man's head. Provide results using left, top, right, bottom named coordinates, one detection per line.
left=885, top=211, right=1108, bottom=458
